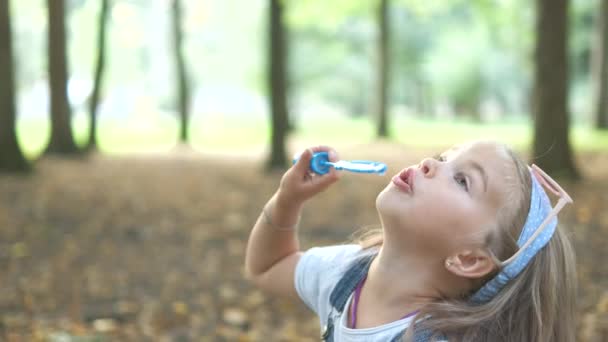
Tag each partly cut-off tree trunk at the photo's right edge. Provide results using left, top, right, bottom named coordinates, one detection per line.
left=591, top=0, right=608, bottom=129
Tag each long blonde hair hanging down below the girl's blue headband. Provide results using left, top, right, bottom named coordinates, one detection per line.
left=405, top=224, right=576, bottom=342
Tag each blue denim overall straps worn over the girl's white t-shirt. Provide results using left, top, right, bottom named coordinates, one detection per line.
left=321, top=254, right=445, bottom=342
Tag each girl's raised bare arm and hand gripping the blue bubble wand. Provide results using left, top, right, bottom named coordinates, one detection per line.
left=245, top=146, right=339, bottom=297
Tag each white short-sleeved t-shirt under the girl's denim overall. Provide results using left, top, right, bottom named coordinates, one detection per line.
left=295, top=245, right=414, bottom=342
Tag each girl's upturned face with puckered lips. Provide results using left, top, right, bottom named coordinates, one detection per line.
left=376, top=142, right=515, bottom=253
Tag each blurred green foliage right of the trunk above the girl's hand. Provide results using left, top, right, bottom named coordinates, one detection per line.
left=289, top=0, right=533, bottom=120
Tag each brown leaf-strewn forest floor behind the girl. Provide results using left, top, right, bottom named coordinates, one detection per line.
left=0, top=143, right=608, bottom=342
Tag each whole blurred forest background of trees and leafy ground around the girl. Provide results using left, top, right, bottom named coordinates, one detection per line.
left=0, top=0, right=608, bottom=342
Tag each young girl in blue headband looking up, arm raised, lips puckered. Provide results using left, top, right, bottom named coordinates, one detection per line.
left=245, top=142, right=576, bottom=342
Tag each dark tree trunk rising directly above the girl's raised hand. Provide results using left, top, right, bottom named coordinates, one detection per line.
left=268, top=0, right=289, bottom=169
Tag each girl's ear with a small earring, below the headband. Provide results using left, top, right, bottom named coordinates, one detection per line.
left=445, top=249, right=496, bottom=279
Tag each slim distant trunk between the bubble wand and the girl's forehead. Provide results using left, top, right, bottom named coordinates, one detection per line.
left=376, top=0, right=390, bottom=138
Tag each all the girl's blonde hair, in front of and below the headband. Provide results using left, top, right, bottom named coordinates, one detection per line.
left=359, top=146, right=576, bottom=342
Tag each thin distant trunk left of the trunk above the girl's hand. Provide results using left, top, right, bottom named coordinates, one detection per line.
left=172, top=0, right=190, bottom=144
